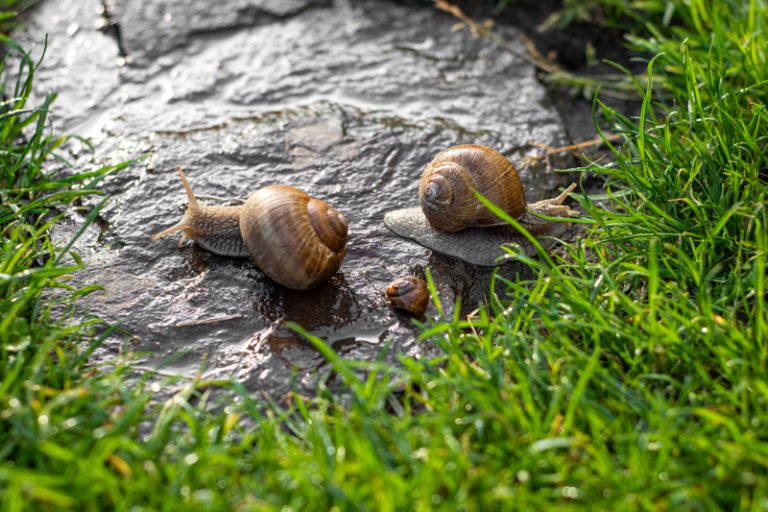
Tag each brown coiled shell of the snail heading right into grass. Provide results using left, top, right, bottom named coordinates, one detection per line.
left=419, top=144, right=525, bottom=233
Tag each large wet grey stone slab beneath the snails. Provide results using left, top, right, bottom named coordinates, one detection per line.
left=13, top=0, right=567, bottom=394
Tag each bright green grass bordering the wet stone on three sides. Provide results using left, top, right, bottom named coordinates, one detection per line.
left=0, top=0, right=768, bottom=511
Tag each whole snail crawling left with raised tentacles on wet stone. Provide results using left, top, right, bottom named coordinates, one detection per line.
left=152, top=166, right=348, bottom=290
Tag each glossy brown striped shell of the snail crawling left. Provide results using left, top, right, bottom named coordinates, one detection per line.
left=240, top=185, right=348, bottom=290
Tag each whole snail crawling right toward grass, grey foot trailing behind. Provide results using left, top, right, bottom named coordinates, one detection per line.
left=384, top=144, right=577, bottom=266
